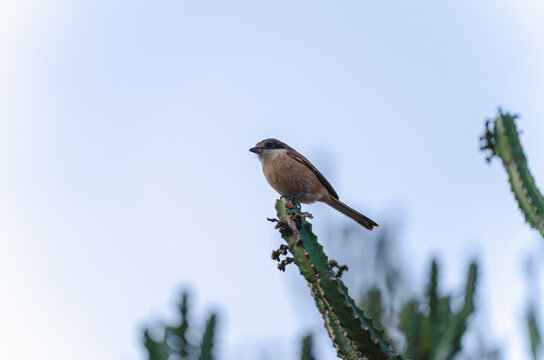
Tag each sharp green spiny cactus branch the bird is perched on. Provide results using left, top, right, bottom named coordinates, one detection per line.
left=276, top=199, right=402, bottom=359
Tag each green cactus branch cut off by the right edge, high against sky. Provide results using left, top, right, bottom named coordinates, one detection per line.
left=480, top=110, right=544, bottom=236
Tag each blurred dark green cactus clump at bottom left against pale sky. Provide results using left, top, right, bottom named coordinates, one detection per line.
left=144, top=293, right=216, bottom=360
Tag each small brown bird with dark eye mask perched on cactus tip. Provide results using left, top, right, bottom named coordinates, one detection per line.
left=249, top=138, right=379, bottom=230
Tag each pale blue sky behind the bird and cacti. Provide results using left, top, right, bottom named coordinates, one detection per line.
left=0, top=0, right=544, bottom=360
